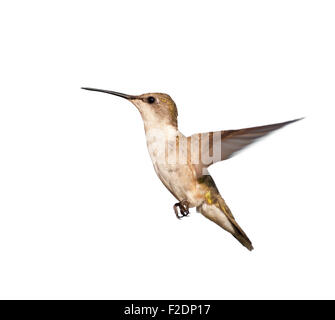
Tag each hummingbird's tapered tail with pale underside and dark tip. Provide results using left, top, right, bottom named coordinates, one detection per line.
left=197, top=197, right=253, bottom=251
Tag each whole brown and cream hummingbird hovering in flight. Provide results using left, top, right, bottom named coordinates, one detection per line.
left=82, top=87, right=302, bottom=251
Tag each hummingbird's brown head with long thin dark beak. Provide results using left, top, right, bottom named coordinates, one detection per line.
left=82, top=87, right=178, bottom=127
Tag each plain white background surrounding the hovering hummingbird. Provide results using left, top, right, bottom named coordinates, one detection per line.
left=0, top=0, right=335, bottom=299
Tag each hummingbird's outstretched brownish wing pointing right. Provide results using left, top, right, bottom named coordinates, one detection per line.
left=188, top=118, right=303, bottom=173
